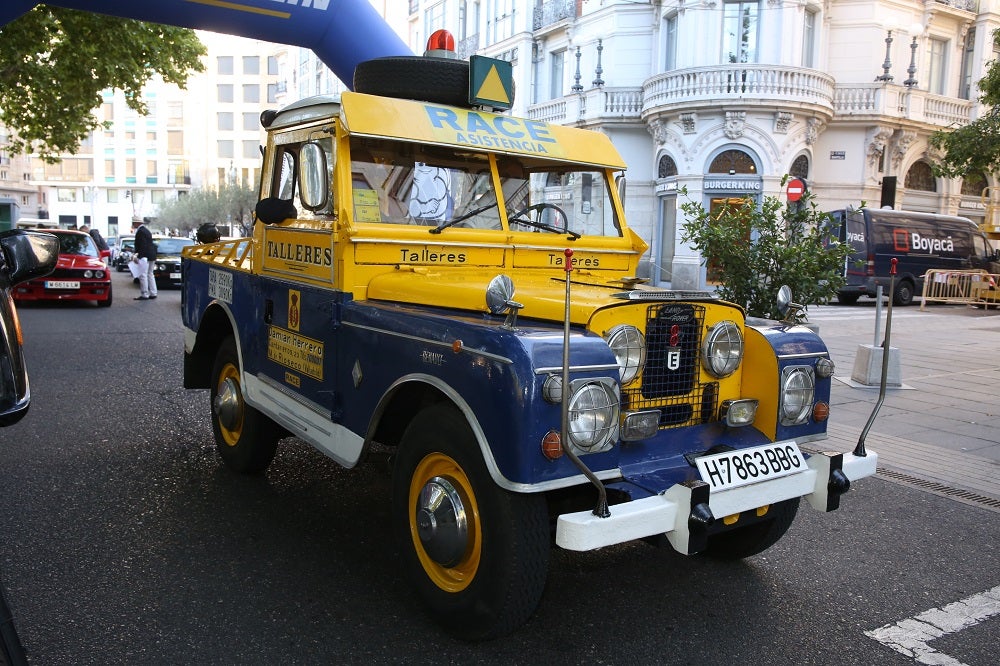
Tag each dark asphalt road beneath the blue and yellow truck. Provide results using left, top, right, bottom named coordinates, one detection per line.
left=0, top=275, right=1000, bottom=666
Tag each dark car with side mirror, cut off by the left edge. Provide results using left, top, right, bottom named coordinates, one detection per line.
left=0, top=229, right=59, bottom=426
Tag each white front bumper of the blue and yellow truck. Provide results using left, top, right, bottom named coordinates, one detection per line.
left=556, top=451, right=878, bottom=553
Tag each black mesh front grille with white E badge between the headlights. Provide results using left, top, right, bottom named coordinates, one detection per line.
left=622, top=303, right=719, bottom=428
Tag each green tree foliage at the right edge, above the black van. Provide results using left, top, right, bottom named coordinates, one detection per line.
left=930, top=30, right=1000, bottom=178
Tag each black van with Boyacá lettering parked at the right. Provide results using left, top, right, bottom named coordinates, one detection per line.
left=831, top=208, right=1000, bottom=305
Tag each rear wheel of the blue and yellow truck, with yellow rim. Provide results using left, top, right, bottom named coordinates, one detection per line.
left=211, top=336, right=280, bottom=474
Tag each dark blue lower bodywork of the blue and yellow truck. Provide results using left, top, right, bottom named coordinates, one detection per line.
left=183, top=260, right=830, bottom=490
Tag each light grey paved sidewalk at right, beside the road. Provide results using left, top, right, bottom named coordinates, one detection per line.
left=810, top=299, right=1000, bottom=510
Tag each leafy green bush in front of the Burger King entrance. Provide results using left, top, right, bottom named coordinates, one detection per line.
left=681, top=187, right=851, bottom=319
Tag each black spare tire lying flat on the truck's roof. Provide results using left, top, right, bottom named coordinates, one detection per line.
left=354, top=56, right=472, bottom=106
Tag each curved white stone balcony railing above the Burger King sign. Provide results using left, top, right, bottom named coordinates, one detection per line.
left=642, top=65, right=834, bottom=111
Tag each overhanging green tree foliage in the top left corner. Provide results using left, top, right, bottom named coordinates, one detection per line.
left=0, top=5, right=206, bottom=162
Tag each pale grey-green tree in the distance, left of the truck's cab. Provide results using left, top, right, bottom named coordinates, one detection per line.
left=156, top=185, right=257, bottom=236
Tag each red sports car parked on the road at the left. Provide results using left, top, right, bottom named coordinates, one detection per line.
left=12, top=229, right=111, bottom=308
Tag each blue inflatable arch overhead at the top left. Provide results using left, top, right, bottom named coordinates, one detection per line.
left=0, top=0, right=413, bottom=87
